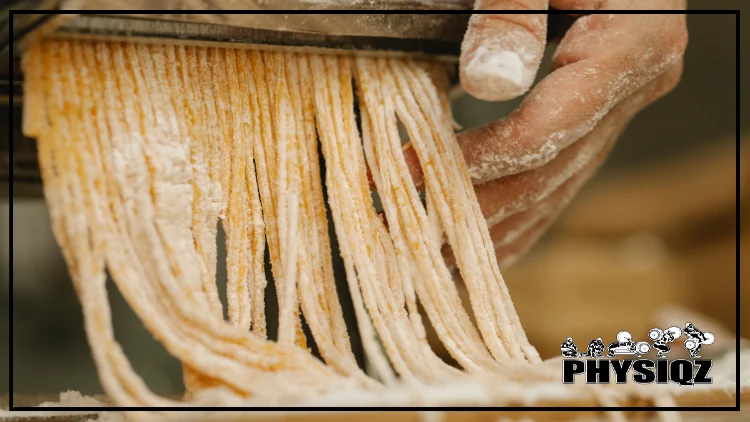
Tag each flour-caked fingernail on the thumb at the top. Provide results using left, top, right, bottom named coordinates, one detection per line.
left=463, top=45, right=534, bottom=101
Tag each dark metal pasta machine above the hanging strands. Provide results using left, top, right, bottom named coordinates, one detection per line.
left=0, top=0, right=473, bottom=198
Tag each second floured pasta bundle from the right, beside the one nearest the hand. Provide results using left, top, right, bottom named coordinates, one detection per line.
left=357, top=58, right=508, bottom=370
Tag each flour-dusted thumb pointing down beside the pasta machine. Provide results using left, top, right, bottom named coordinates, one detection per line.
left=460, top=0, right=548, bottom=101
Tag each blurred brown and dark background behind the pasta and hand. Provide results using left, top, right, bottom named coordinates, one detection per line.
left=0, top=9, right=750, bottom=396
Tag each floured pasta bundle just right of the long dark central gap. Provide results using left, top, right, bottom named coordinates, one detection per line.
left=311, top=57, right=452, bottom=382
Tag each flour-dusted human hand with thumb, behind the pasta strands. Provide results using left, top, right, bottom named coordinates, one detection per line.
left=404, top=0, right=687, bottom=266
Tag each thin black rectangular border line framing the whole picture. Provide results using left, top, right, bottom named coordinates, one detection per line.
left=8, top=9, right=741, bottom=416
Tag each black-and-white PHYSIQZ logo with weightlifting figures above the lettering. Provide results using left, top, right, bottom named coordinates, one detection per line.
left=560, top=322, right=715, bottom=385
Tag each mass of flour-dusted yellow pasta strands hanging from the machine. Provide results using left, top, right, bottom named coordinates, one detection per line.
left=23, top=40, right=680, bottom=418
